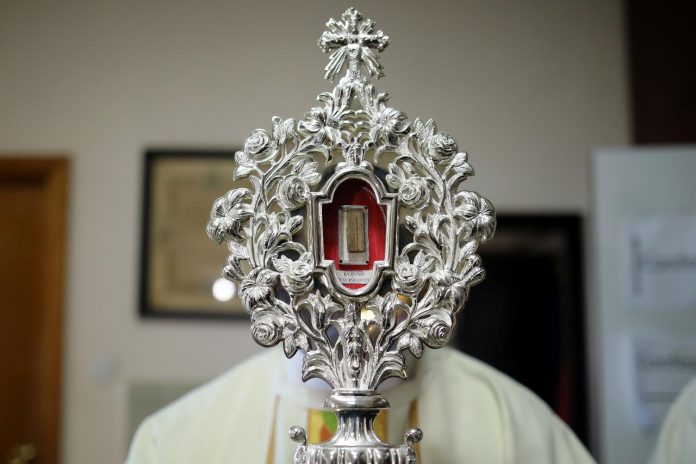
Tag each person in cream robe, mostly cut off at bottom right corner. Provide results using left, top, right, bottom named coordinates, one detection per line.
left=651, top=379, right=696, bottom=464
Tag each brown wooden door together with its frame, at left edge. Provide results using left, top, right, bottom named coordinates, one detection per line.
left=0, top=156, right=68, bottom=464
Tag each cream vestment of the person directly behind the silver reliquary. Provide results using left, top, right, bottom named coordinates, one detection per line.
left=127, top=348, right=594, bottom=464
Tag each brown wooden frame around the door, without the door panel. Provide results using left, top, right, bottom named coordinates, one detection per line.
left=0, top=155, right=69, bottom=463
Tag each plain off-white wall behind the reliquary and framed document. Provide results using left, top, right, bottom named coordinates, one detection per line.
left=0, top=0, right=628, bottom=464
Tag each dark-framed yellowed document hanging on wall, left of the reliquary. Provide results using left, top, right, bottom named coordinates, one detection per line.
left=140, top=149, right=246, bottom=318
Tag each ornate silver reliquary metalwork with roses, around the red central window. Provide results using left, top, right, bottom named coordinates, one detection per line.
left=207, top=8, right=495, bottom=464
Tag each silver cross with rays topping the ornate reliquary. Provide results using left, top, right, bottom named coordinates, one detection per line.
left=319, top=7, right=389, bottom=81
